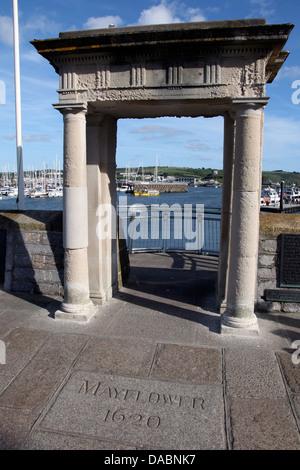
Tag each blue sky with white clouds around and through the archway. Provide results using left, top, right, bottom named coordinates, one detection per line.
left=0, top=0, right=300, bottom=171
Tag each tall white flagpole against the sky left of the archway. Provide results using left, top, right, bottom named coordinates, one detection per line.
left=13, top=0, right=25, bottom=210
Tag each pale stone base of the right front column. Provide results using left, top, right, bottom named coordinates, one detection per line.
left=221, top=313, right=259, bottom=337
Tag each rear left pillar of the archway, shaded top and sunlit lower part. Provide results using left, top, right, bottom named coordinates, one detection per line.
left=87, top=112, right=118, bottom=304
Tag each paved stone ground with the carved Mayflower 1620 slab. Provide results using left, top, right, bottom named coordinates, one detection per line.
left=0, top=253, right=300, bottom=450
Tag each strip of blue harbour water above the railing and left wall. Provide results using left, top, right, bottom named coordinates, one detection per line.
left=0, top=187, right=222, bottom=211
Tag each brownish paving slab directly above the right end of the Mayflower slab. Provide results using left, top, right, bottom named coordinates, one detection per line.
left=152, top=344, right=222, bottom=385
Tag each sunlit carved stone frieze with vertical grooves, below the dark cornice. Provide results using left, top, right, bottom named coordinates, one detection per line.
left=51, top=46, right=270, bottom=103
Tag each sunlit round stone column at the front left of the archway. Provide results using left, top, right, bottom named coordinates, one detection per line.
left=55, top=103, right=96, bottom=322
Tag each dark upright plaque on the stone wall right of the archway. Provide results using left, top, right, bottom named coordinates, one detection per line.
left=280, top=234, right=300, bottom=287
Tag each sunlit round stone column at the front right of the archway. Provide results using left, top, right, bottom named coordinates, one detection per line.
left=221, top=98, right=267, bottom=336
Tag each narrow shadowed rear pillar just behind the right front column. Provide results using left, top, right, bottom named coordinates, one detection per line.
left=217, top=112, right=235, bottom=313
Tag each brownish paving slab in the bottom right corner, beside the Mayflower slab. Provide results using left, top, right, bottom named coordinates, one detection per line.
left=230, top=398, right=300, bottom=450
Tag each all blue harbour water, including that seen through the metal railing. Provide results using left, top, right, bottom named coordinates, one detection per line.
left=0, top=187, right=222, bottom=254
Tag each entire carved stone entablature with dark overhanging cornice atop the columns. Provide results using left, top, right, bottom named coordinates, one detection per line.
left=32, top=20, right=293, bottom=112
